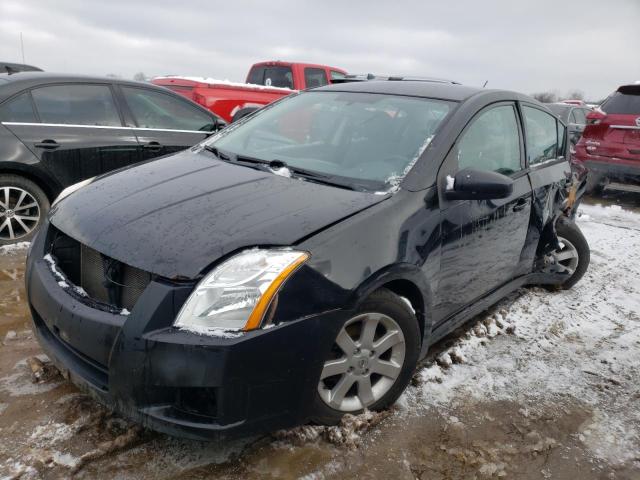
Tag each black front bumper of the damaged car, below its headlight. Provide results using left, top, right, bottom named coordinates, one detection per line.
left=26, top=228, right=348, bottom=439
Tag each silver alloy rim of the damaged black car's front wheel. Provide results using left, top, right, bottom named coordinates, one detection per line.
left=318, top=313, right=406, bottom=412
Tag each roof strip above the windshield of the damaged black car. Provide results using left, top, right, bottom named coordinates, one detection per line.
left=313, top=80, right=484, bottom=102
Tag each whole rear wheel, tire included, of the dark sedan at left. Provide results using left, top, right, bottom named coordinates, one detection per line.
left=0, top=174, right=51, bottom=245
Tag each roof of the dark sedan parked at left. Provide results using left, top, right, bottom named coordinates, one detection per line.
left=0, top=72, right=168, bottom=102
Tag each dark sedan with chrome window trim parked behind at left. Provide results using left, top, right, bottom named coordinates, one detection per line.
left=0, top=72, right=224, bottom=245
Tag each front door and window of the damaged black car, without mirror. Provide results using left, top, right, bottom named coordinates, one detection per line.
left=433, top=102, right=532, bottom=324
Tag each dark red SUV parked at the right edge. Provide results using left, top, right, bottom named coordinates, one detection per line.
left=574, top=84, right=640, bottom=190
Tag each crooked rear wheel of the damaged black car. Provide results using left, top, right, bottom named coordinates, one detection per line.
left=546, top=217, right=591, bottom=290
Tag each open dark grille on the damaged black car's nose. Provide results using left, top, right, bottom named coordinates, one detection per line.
left=49, top=227, right=151, bottom=310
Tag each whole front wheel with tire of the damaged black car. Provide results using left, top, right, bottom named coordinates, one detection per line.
left=312, top=288, right=421, bottom=425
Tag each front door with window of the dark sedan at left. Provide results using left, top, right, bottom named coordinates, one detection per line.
left=120, top=85, right=217, bottom=160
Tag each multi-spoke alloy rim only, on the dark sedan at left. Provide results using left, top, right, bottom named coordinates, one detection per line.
left=0, top=186, right=40, bottom=240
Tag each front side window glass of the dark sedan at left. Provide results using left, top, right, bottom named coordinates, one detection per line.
left=122, top=87, right=215, bottom=132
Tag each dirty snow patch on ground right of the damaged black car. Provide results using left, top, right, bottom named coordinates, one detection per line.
left=399, top=205, right=640, bottom=464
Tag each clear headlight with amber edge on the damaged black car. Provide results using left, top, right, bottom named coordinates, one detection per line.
left=175, top=248, right=309, bottom=333
